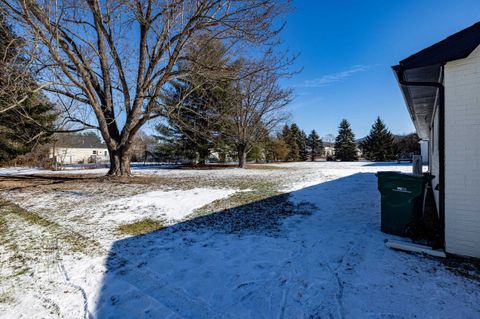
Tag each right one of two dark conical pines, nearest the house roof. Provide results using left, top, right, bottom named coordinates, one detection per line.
left=362, top=117, right=396, bottom=162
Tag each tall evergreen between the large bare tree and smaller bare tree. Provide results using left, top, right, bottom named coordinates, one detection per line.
left=157, top=38, right=231, bottom=164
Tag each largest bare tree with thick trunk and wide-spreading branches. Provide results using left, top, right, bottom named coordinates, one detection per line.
left=0, top=0, right=290, bottom=175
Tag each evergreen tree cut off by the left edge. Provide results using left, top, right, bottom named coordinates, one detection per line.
left=0, top=13, right=57, bottom=162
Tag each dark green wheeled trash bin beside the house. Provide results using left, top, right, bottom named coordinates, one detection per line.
left=376, top=172, right=430, bottom=236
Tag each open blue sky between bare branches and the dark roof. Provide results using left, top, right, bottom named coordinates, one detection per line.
left=282, top=0, right=480, bottom=137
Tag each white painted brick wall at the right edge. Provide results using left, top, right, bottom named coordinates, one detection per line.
left=445, top=47, right=480, bottom=258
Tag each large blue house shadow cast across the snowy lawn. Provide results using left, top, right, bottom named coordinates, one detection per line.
left=90, top=173, right=480, bottom=319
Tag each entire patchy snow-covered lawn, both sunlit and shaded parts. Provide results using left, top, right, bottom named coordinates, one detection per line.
left=0, top=162, right=480, bottom=318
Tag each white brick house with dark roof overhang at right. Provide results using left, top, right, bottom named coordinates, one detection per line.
left=393, top=23, right=480, bottom=258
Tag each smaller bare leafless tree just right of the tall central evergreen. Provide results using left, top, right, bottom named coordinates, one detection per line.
left=225, top=67, right=292, bottom=168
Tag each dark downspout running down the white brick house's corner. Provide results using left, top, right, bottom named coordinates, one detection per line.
left=396, top=64, right=445, bottom=248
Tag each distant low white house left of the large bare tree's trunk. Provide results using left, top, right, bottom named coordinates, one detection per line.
left=50, top=134, right=109, bottom=164
